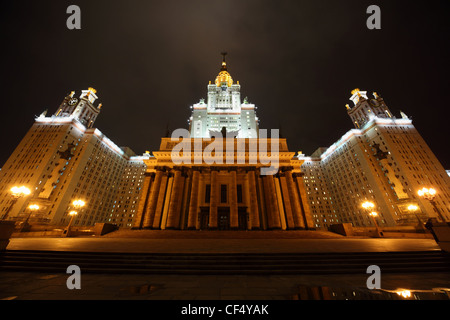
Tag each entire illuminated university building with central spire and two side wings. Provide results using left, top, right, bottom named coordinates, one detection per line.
left=0, top=55, right=450, bottom=230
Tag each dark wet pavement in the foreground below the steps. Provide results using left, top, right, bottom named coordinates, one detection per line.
left=0, top=272, right=450, bottom=300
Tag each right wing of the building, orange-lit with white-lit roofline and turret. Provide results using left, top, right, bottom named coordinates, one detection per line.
left=299, top=89, right=450, bottom=228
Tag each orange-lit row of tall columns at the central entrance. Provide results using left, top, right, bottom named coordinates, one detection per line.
left=133, top=166, right=314, bottom=230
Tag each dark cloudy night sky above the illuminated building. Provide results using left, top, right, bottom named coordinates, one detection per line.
left=0, top=0, right=450, bottom=169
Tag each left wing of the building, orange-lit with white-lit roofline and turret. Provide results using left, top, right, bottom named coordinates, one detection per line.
left=0, top=88, right=145, bottom=226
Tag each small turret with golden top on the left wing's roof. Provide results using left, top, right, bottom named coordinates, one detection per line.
left=54, top=88, right=102, bottom=128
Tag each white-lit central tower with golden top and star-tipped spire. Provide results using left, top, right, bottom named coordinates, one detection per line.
left=189, top=52, right=259, bottom=138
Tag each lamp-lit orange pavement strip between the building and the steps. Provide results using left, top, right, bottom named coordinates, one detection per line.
left=7, top=237, right=440, bottom=253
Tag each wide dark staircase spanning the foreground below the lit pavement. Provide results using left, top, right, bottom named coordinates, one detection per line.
left=0, top=250, right=450, bottom=275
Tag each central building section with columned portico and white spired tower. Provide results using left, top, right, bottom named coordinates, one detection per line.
left=134, top=59, right=314, bottom=230
